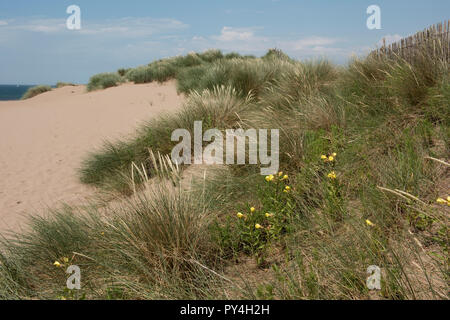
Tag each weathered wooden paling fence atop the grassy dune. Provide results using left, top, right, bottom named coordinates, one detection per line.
left=371, top=20, right=450, bottom=63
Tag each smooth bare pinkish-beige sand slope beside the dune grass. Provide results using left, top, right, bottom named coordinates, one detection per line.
left=0, top=81, right=183, bottom=231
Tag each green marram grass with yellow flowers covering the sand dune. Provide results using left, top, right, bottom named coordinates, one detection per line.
left=0, top=40, right=450, bottom=299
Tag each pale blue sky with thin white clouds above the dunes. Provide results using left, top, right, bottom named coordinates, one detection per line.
left=0, top=0, right=450, bottom=84
